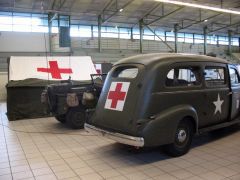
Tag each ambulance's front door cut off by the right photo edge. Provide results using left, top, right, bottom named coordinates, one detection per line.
left=228, top=65, right=240, bottom=120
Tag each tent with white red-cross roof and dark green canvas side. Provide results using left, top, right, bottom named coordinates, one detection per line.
left=6, top=56, right=96, bottom=120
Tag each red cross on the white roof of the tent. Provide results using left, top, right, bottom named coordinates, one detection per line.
left=37, top=61, right=73, bottom=79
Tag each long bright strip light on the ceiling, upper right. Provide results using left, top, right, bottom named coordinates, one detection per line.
left=155, top=0, right=240, bottom=15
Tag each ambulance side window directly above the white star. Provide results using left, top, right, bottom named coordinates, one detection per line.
left=204, top=67, right=226, bottom=87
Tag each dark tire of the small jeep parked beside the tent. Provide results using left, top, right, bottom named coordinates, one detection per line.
left=66, top=107, right=86, bottom=129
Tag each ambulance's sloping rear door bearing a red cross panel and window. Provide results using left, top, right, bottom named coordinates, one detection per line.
left=92, top=64, right=144, bottom=134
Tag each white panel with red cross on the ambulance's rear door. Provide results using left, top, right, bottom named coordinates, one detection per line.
left=104, top=82, right=130, bottom=111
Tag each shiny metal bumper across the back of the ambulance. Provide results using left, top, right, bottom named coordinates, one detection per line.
left=84, top=123, right=144, bottom=147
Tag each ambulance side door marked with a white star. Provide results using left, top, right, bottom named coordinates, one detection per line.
left=200, top=63, right=231, bottom=127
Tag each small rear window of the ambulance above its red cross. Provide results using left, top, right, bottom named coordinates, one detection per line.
left=113, top=67, right=138, bottom=79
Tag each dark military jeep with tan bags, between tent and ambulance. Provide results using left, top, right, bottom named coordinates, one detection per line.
left=41, top=74, right=106, bottom=129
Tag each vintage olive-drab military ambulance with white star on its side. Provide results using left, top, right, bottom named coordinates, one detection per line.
left=85, top=54, right=240, bottom=156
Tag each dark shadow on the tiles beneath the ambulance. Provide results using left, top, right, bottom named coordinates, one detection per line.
left=94, top=125, right=240, bottom=165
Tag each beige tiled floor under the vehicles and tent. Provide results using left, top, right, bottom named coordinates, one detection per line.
left=0, top=103, right=240, bottom=180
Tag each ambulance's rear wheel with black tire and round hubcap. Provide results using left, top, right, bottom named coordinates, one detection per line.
left=165, top=120, right=193, bottom=157
